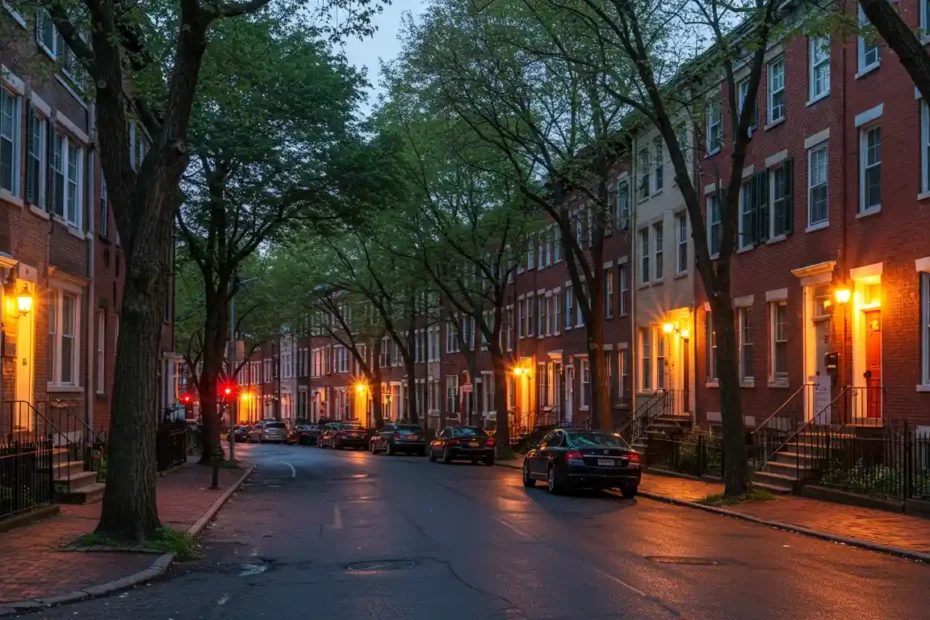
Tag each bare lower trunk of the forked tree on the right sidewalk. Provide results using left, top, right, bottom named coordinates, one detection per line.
left=711, top=293, right=749, bottom=496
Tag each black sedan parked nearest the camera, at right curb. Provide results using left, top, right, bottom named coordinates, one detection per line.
left=523, top=429, right=642, bottom=497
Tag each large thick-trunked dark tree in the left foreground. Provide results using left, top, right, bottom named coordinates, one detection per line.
left=39, top=0, right=379, bottom=541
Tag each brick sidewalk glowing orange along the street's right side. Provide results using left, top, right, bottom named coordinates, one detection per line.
left=498, top=456, right=930, bottom=562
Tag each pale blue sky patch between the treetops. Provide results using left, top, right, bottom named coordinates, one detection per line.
left=343, top=0, right=426, bottom=114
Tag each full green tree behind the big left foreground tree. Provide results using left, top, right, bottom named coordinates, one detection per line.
left=176, top=18, right=364, bottom=463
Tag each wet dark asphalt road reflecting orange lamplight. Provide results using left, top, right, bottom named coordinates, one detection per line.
left=33, top=445, right=930, bottom=620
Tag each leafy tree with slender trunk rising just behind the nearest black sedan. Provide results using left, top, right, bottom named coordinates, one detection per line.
left=388, top=0, right=629, bottom=429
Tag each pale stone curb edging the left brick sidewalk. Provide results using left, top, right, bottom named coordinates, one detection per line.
left=0, top=465, right=255, bottom=616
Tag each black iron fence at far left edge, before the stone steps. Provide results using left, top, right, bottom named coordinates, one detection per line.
left=0, top=439, right=55, bottom=519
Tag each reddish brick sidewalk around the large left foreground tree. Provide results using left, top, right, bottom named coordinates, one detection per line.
left=0, top=463, right=243, bottom=604
